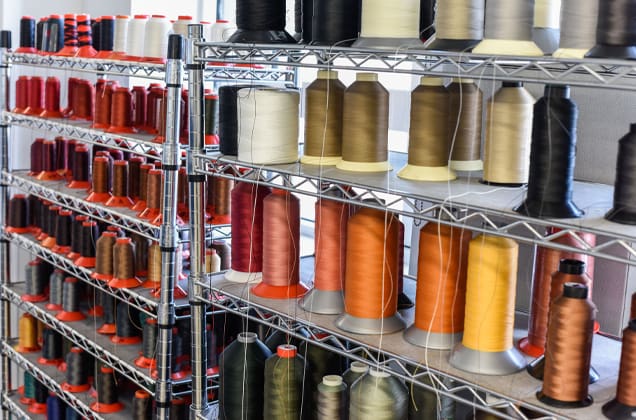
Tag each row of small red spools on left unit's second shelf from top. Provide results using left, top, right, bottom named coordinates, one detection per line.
left=12, top=76, right=218, bottom=145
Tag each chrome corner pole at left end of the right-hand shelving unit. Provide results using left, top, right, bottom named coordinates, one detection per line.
left=186, top=25, right=208, bottom=419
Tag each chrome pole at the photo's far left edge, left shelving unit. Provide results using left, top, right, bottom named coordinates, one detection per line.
left=0, top=31, right=12, bottom=398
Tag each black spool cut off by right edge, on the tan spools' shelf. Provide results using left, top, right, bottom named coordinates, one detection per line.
left=605, top=124, right=636, bottom=225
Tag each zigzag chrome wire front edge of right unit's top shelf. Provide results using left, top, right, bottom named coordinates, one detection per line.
left=196, top=42, right=636, bottom=91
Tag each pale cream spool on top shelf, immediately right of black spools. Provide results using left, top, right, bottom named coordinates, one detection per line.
left=353, top=0, right=422, bottom=48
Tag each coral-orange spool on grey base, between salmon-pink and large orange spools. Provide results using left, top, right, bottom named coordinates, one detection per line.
left=300, top=198, right=350, bottom=315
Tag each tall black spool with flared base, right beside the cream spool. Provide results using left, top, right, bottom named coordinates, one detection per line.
left=515, top=85, right=583, bottom=219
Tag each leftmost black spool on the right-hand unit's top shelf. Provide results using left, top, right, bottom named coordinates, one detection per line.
left=228, top=0, right=296, bottom=44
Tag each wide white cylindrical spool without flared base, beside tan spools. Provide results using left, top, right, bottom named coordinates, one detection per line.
left=237, top=87, right=300, bottom=165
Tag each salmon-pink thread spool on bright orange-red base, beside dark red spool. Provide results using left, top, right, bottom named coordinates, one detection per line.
left=252, top=190, right=307, bottom=299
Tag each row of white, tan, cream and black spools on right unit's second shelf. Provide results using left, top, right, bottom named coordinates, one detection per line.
left=219, top=71, right=636, bottom=224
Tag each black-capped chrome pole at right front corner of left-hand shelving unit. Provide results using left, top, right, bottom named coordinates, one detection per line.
left=155, top=35, right=183, bottom=420
